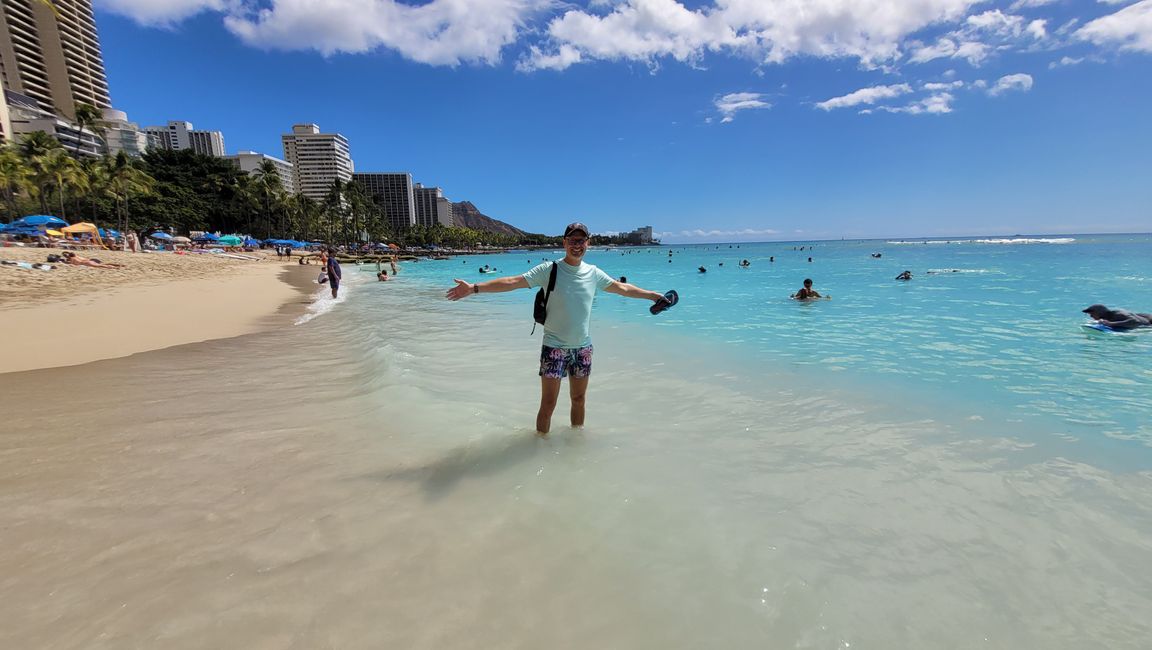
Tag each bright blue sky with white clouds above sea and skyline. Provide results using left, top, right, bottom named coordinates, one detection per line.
left=96, top=0, right=1152, bottom=243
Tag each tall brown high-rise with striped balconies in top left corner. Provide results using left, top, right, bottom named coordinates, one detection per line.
left=0, top=0, right=112, bottom=120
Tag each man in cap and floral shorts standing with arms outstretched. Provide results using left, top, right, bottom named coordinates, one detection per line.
left=446, top=222, right=665, bottom=433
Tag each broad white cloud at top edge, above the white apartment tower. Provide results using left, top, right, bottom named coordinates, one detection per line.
left=225, top=0, right=557, bottom=66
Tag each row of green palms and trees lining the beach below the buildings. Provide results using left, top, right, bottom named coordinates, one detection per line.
left=0, top=137, right=612, bottom=249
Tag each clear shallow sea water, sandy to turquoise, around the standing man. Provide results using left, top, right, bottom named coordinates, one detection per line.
left=0, top=236, right=1152, bottom=649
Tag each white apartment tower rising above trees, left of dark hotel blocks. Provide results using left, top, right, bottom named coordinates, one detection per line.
left=280, top=124, right=354, bottom=201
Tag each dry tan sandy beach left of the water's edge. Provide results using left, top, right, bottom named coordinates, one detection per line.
left=0, top=248, right=314, bottom=372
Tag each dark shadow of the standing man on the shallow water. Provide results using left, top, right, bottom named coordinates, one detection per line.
left=364, top=429, right=584, bottom=499
